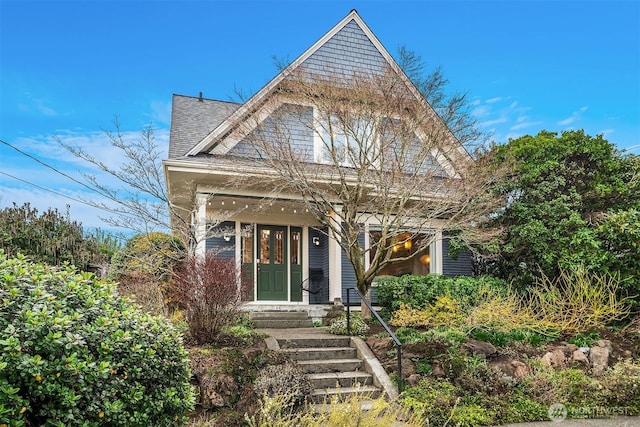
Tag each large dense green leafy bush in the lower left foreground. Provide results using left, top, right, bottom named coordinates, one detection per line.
left=0, top=251, right=194, bottom=426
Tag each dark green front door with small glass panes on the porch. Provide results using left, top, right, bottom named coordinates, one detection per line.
left=258, top=225, right=289, bottom=301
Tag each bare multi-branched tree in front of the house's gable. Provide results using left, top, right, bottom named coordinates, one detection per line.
left=232, top=67, right=508, bottom=304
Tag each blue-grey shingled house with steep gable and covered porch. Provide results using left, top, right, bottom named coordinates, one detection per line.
left=164, top=10, right=471, bottom=305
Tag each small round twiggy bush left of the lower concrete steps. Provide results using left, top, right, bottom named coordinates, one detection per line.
left=253, top=362, right=312, bottom=408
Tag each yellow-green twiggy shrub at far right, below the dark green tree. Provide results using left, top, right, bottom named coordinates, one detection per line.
left=527, top=267, right=631, bottom=333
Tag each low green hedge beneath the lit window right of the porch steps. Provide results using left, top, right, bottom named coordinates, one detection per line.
left=376, top=274, right=508, bottom=316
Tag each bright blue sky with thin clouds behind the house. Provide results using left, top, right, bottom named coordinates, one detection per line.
left=0, top=0, right=640, bottom=231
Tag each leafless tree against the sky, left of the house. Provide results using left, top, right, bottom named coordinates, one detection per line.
left=56, top=116, right=235, bottom=254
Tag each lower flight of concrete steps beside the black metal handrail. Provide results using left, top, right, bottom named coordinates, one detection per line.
left=276, top=335, right=384, bottom=404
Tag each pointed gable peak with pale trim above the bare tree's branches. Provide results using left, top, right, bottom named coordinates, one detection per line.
left=186, top=9, right=455, bottom=156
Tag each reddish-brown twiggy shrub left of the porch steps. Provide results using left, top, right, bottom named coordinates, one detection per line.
left=170, top=254, right=246, bottom=344
